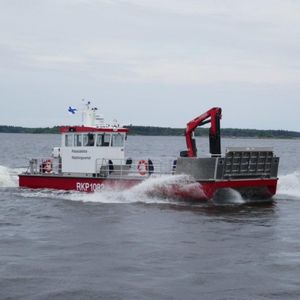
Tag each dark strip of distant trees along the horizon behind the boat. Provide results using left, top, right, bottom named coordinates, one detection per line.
left=0, top=125, right=300, bottom=139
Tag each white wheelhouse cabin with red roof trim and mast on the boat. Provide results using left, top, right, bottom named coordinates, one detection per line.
left=53, top=105, right=128, bottom=174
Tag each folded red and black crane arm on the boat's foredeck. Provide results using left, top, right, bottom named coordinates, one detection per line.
left=185, top=107, right=222, bottom=157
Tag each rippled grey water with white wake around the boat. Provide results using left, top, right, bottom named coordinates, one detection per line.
left=0, top=134, right=300, bottom=300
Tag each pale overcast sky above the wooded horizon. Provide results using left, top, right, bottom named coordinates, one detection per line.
left=0, top=0, right=300, bottom=131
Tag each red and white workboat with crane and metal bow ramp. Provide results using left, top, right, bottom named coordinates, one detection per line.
left=19, top=102, right=279, bottom=200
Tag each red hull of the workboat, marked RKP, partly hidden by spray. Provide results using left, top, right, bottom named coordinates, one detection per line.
left=19, top=174, right=277, bottom=200
